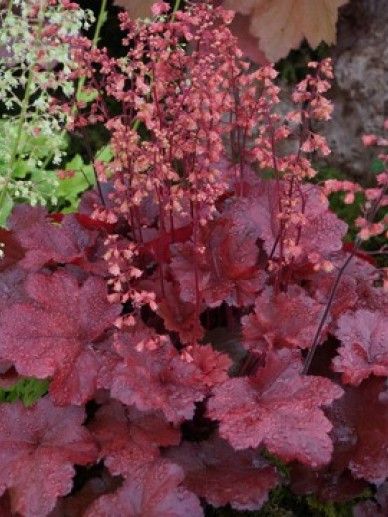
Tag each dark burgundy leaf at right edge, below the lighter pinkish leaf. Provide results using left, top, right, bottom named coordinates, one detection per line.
left=327, top=377, right=388, bottom=484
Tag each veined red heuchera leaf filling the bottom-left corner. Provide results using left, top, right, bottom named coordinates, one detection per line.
left=0, top=397, right=97, bottom=517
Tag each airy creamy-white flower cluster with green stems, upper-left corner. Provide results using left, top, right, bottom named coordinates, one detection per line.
left=0, top=0, right=94, bottom=222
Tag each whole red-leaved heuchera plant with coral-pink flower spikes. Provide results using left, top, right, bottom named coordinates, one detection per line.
left=0, top=2, right=388, bottom=517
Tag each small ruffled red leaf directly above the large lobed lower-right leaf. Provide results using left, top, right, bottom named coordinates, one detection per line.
left=241, top=285, right=324, bottom=352
